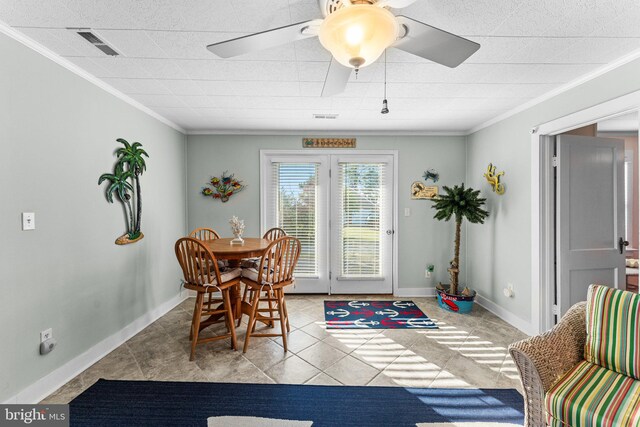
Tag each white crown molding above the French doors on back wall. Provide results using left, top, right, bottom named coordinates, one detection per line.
left=186, top=129, right=469, bottom=137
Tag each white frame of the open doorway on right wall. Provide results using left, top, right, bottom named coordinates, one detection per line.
left=531, top=90, right=640, bottom=333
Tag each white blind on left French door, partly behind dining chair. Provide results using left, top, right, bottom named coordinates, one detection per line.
left=272, top=163, right=320, bottom=277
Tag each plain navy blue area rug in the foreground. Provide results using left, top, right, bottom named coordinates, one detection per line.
left=70, top=380, right=524, bottom=427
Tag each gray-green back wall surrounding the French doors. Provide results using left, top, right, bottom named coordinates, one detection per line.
left=187, top=134, right=465, bottom=288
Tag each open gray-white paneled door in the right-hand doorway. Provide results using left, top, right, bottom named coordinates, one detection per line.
left=556, top=135, right=625, bottom=315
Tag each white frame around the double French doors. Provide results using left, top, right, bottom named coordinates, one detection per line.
left=258, top=148, right=399, bottom=295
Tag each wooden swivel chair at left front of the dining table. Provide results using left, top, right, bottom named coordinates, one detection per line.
left=175, top=237, right=242, bottom=360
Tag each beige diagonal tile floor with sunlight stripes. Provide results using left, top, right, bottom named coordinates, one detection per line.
left=44, top=295, right=526, bottom=403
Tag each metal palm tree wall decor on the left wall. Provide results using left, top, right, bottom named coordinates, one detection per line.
left=98, top=138, right=149, bottom=245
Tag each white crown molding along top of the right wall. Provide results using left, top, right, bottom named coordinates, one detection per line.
left=466, top=49, right=640, bottom=135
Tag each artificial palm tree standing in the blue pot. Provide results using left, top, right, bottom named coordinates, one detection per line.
left=432, top=184, right=489, bottom=295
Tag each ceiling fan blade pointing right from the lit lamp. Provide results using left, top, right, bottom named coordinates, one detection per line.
left=392, top=16, right=480, bottom=68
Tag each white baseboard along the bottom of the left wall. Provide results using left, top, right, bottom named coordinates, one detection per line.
left=4, top=290, right=188, bottom=404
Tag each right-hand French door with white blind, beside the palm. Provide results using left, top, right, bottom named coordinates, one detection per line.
left=330, top=155, right=394, bottom=294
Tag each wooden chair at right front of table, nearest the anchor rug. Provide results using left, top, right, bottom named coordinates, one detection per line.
left=242, top=236, right=301, bottom=353
